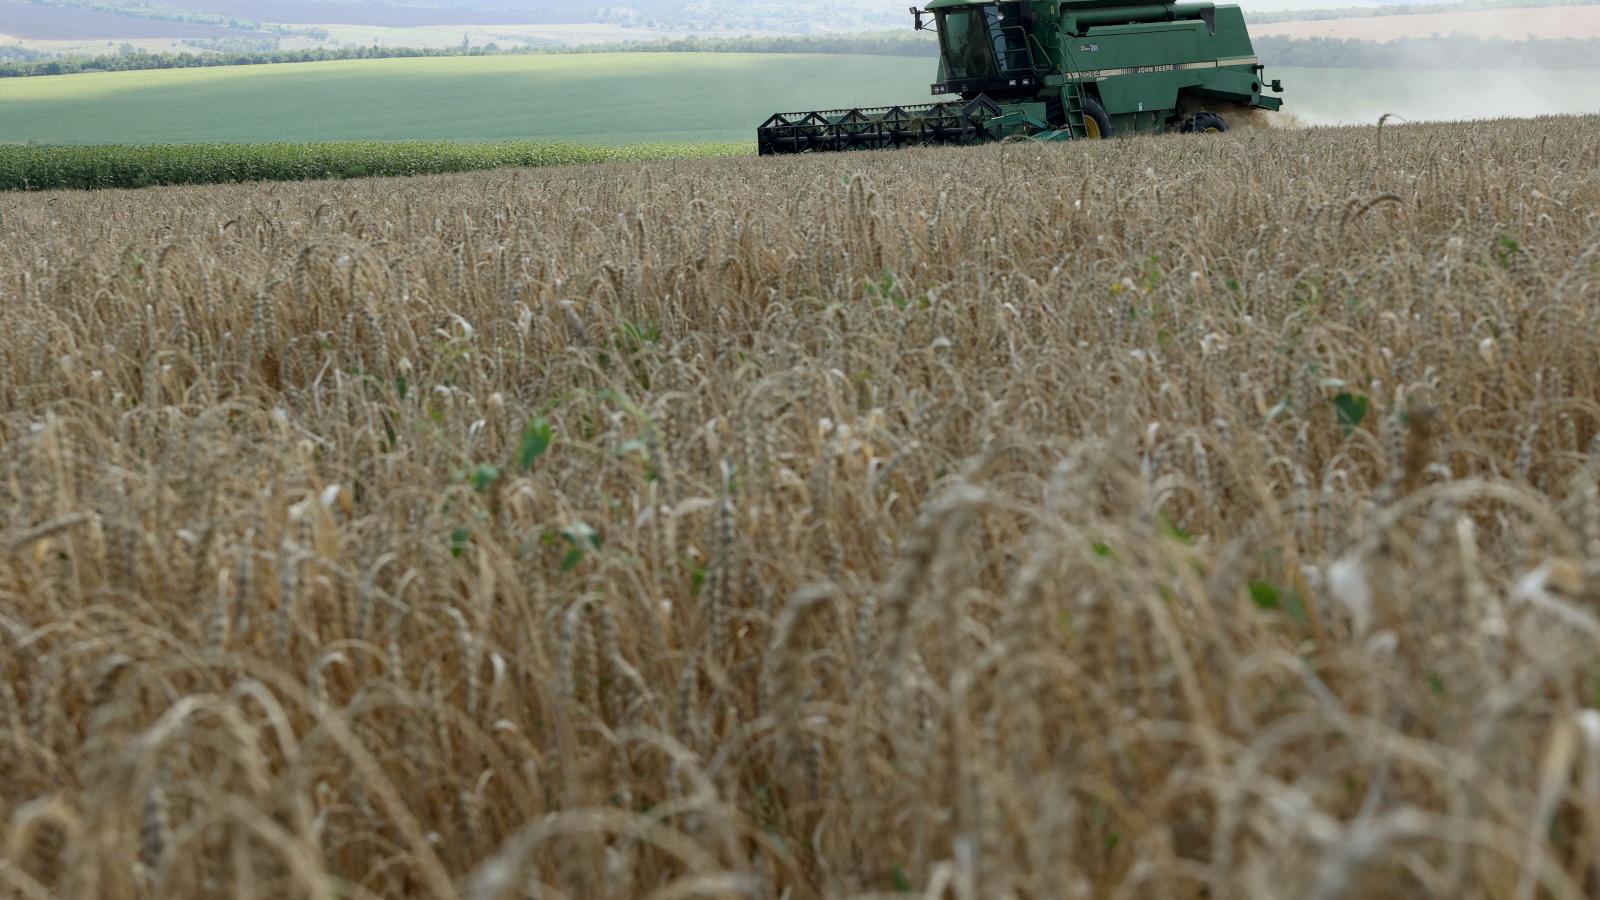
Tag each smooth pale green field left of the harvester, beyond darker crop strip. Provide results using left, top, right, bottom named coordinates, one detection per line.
left=0, top=53, right=934, bottom=144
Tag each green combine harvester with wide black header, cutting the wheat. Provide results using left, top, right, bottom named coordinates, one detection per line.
left=757, top=0, right=1283, bottom=155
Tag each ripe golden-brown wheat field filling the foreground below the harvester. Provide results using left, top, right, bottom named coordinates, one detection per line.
left=0, top=119, right=1600, bottom=900
